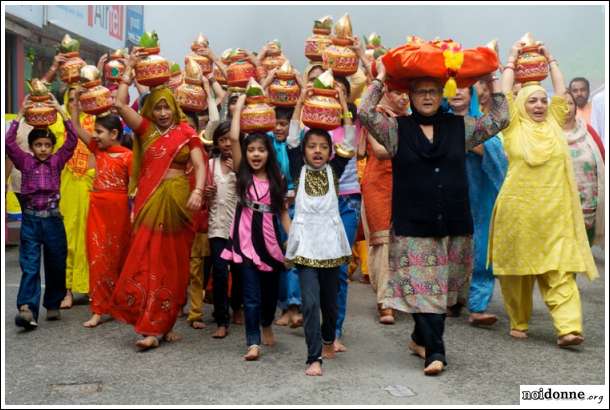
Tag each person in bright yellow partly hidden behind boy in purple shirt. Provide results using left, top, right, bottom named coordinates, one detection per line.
left=50, top=86, right=95, bottom=309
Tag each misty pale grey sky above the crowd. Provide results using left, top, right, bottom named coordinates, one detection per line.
left=144, top=3, right=607, bottom=91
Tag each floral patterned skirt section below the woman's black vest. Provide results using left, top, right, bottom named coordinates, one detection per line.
left=383, top=234, right=473, bottom=314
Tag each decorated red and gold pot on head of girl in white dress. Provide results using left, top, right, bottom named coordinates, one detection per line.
left=301, top=88, right=343, bottom=131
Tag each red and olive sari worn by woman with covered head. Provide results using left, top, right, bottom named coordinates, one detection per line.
left=111, top=113, right=201, bottom=336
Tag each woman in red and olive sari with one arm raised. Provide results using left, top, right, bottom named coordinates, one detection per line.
left=111, top=55, right=205, bottom=349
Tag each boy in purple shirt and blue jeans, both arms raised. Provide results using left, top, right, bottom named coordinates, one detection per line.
left=6, top=97, right=77, bottom=330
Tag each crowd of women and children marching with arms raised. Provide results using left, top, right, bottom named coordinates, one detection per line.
left=6, top=30, right=605, bottom=376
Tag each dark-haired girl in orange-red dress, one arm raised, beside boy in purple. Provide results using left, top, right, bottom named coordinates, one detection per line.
left=71, top=100, right=132, bottom=328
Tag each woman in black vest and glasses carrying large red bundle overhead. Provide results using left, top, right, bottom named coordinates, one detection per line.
left=359, top=60, right=508, bottom=375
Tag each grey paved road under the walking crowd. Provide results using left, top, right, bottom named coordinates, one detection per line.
left=3, top=248, right=606, bottom=405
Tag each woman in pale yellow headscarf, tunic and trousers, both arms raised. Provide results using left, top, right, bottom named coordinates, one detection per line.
left=488, top=43, right=598, bottom=347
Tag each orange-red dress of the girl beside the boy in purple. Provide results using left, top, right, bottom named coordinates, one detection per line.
left=87, top=141, right=132, bottom=315
